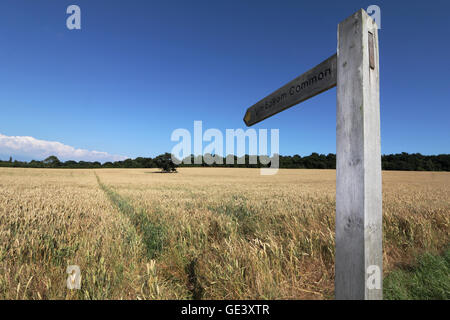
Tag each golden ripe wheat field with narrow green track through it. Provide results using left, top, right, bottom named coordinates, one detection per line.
left=0, top=168, right=450, bottom=299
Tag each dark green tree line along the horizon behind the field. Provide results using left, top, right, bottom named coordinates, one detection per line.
left=0, top=152, right=450, bottom=172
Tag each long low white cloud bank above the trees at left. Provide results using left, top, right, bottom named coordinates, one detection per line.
left=0, top=133, right=127, bottom=162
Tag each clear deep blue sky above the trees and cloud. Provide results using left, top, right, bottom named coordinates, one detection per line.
left=0, top=0, right=450, bottom=160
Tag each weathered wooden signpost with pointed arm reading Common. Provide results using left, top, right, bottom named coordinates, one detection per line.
left=244, top=9, right=383, bottom=299
